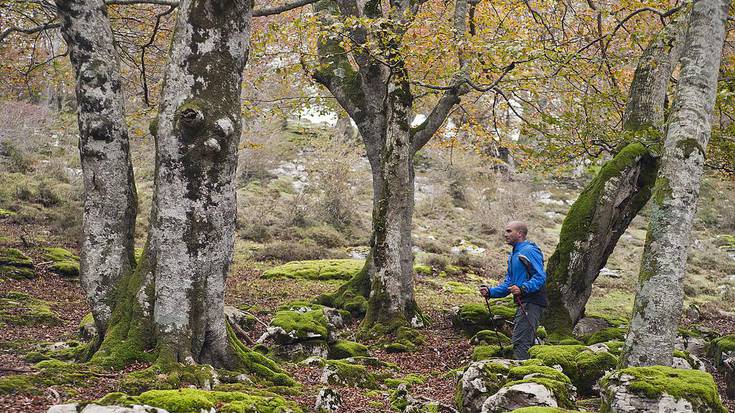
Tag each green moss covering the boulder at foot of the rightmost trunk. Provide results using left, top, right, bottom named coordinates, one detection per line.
left=600, top=366, right=727, bottom=413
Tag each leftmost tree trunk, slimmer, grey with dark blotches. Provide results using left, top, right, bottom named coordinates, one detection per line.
left=56, top=0, right=138, bottom=338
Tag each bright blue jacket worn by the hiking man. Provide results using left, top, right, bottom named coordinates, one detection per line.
left=490, top=241, right=547, bottom=307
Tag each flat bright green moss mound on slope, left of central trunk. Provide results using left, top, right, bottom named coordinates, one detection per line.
left=263, top=259, right=365, bottom=280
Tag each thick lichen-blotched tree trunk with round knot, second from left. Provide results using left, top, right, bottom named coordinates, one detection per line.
left=147, top=0, right=252, bottom=366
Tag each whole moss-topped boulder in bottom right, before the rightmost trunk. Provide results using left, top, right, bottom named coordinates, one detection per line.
left=600, top=366, right=727, bottom=413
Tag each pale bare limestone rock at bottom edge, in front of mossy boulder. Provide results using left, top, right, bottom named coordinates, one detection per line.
left=481, top=383, right=558, bottom=413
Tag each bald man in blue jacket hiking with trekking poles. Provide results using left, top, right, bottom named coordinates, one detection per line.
left=480, top=221, right=547, bottom=360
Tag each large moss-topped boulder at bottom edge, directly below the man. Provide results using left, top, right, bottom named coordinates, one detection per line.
left=455, top=359, right=575, bottom=413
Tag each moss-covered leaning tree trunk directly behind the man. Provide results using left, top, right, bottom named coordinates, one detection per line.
left=544, top=15, right=684, bottom=337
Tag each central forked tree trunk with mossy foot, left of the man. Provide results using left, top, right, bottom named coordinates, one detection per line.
left=314, top=0, right=466, bottom=332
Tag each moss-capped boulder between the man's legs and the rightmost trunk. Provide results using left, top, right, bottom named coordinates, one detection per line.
left=529, top=345, right=618, bottom=394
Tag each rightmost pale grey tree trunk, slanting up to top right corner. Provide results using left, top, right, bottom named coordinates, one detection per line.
left=621, top=0, right=730, bottom=366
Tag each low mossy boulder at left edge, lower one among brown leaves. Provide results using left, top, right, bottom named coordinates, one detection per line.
left=0, top=291, right=61, bottom=326
